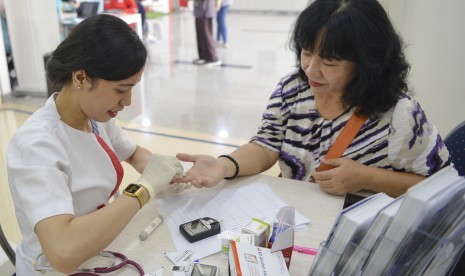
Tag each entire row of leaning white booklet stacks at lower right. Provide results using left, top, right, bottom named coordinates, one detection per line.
left=310, top=167, right=465, bottom=276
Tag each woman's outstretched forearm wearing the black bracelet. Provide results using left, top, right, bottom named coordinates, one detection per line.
left=220, top=143, right=279, bottom=179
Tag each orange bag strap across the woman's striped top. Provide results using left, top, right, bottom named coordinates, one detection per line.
left=316, top=112, right=367, bottom=172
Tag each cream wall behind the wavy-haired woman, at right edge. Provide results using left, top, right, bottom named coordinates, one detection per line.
left=380, top=0, right=465, bottom=137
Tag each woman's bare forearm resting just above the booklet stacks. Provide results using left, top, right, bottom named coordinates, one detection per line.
left=359, top=166, right=426, bottom=197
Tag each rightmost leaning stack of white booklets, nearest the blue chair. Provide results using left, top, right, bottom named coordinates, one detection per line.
left=362, top=168, right=465, bottom=275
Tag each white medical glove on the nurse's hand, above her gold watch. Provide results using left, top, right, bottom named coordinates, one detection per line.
left=135, top=153, right=184, bottom=200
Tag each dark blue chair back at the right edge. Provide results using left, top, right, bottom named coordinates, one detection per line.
left=444, top=121, right=465, bottom=176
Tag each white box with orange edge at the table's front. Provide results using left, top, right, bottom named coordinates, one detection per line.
left=229, top=241, right=289, bottom=276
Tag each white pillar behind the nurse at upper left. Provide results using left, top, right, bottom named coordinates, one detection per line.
left=4, top=0, right=60, bottom=96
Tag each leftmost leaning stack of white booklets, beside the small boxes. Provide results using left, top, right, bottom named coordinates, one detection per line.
left=311, top=193, right=394, bottom=275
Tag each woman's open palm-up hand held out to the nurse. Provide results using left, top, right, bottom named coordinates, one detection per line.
left=173, top=153, right=228, bottom=188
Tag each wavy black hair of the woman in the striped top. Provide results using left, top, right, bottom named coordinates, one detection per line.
left=290, top=0, right=410, bottom=118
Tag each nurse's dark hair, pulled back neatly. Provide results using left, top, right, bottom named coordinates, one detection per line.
left=46, top=14, right=147, bottom=91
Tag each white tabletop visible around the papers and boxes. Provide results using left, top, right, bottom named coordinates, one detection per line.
left=107, top=175, right=343, bottom=276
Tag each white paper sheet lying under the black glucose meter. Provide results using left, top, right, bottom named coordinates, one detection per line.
left=158, top=183, right=310, bottom=260
